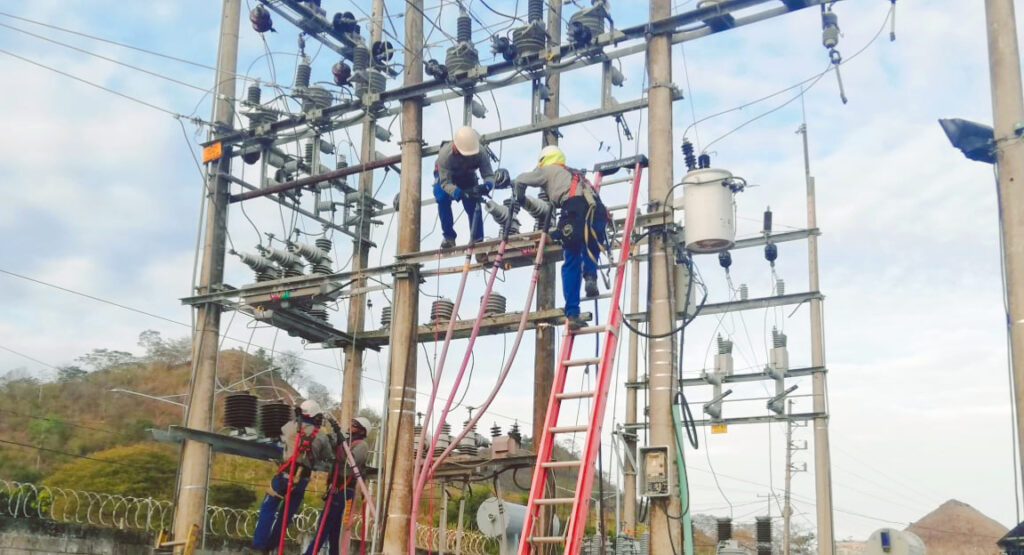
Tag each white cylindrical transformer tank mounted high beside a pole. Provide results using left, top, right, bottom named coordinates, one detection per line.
left=676, top=168, right=736, bottom=253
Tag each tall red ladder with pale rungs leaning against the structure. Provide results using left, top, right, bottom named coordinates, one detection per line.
left=518, top=156, right=647, bottom=555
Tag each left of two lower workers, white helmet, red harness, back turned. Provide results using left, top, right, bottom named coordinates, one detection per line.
left=253, top=399, right=332, bottom=552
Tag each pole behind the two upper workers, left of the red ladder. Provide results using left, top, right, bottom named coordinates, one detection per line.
left=532, top=2, right=562, bottom=460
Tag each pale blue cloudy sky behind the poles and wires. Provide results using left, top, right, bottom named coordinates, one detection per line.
left=0, top=0, right=1020, bottom=539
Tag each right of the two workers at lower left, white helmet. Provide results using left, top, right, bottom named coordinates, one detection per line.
left=305, top=417, right=370, bottom=555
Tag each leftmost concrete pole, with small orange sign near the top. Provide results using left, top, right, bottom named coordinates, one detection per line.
left=174, top=0, right=242, bottom=540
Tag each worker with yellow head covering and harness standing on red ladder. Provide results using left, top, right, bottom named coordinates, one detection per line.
left=515, top=145, right=608, bottom=330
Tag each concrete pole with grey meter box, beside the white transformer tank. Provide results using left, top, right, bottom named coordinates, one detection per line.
left=647, top=0, right=683, bottom=553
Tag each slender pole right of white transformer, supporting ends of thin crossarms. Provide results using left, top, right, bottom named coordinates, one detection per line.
left=798, top=123, right=836, bottom=555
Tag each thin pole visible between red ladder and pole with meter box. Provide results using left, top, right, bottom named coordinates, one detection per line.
left=618, top=254, right=640, bottom=538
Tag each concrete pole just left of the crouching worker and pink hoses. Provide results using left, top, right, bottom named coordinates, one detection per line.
left=382, top=0, right=423, bottom=554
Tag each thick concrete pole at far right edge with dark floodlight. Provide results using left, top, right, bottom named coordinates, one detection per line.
left=985, top=0, right=1024, bottom=507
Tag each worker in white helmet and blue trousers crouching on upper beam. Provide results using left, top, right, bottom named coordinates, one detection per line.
left=434, top=126, right=495, bottom=249
